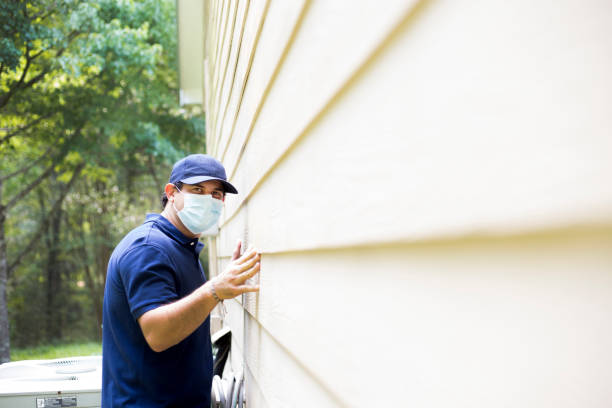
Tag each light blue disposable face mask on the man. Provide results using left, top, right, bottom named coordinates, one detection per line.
left=172, top=190, right=223, bottom=234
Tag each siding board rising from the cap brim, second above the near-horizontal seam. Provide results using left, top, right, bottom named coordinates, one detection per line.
left=225, top=0, right=415, bottom=213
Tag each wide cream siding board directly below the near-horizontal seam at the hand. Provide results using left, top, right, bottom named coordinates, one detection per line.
left=246, top=230, right=612, bottom=408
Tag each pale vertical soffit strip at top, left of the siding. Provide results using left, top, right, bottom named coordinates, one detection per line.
left=176, top=0, right=204, bottom=105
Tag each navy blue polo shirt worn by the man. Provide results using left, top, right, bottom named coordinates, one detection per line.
left=102, top=214, right=213, bottom=407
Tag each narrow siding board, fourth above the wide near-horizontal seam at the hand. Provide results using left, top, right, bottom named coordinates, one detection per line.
left=212, top=0, right=270, bottom=157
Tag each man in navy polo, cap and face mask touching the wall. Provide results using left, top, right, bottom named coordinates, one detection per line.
left=102, top=154, right=260, bottom=407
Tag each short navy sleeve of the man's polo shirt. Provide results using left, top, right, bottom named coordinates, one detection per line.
left=119, top=245, right=179, bottom=320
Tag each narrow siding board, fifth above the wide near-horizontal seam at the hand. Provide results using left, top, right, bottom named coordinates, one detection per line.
left=209, top=1, right=249, bottom=142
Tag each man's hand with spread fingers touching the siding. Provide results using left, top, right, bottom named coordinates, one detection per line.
left=211, top=241, right=260, bottom=299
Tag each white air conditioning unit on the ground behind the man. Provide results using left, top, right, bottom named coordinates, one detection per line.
left=0, top=356, right=102, bottom=408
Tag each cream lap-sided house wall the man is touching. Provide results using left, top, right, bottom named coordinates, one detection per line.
left=194, top=0, right=612, bottom=407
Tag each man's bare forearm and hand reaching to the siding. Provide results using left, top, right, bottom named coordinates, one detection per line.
left=138, top=242, right=260, bottom=352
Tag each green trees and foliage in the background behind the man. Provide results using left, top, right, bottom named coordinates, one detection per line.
left=0, top=0, right=204, bottom=357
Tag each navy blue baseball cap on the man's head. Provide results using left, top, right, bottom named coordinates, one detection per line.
left=168, top=154, right=238, bottom=194
